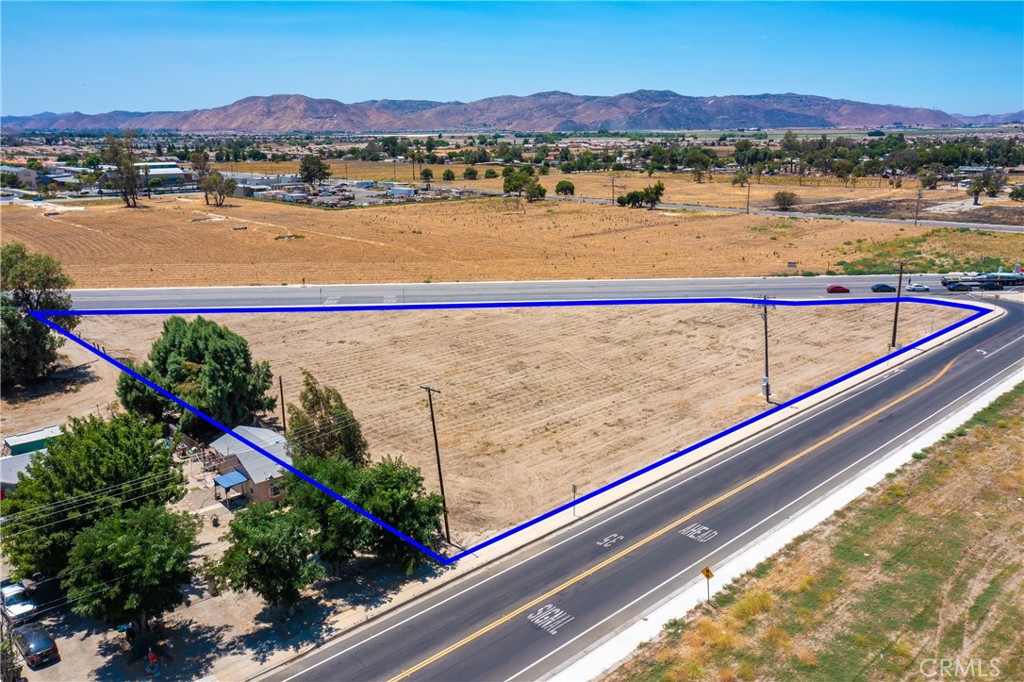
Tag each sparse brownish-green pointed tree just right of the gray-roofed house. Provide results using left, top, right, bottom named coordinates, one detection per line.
left=288, top=370, right=370, bottom=466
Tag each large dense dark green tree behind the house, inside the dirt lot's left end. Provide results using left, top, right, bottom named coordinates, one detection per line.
left=118, top=315, right=276, bottom=432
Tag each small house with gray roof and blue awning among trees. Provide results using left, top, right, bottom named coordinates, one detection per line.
left=210, top=426, right=292, bottom=502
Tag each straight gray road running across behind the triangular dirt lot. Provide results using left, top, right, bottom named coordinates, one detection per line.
left=64, top=274, right=999, bottom=310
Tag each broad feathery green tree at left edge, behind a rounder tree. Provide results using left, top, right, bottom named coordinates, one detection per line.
left=0, top=414, right=184, bottom=577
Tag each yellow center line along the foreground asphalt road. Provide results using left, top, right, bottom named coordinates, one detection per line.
left=388, top=355, right=963, bottom=682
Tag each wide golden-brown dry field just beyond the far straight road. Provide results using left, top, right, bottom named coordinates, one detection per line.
left=0, top=196, right=1024, bottom=288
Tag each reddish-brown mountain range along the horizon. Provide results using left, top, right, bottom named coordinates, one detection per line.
left=0, top=90, right=1007, bottom=133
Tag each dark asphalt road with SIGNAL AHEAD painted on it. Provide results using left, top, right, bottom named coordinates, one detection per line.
left=260, top=294, right=1024, bottom=681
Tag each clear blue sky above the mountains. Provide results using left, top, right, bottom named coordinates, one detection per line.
left=0, top=0, right=1024, bottom=115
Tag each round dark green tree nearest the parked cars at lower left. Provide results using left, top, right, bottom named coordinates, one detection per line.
left=61, top=504, right=202, bottom=632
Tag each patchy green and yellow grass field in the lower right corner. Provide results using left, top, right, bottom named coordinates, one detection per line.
left=605, top=385, right=1024, bottom=682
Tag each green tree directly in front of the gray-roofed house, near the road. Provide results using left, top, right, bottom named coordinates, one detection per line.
left=207, top=502, right=325, bottom=607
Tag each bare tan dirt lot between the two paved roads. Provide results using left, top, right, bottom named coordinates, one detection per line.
left=4, top=305, right=961, bottom=543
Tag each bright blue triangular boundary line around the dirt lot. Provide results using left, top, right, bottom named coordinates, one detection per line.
left=29, top=296, right=994, bottom=565
